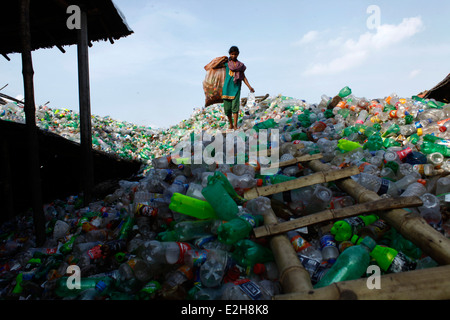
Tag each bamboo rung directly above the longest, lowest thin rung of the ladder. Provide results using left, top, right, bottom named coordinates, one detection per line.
left=244, top=165, right=359, bottom=200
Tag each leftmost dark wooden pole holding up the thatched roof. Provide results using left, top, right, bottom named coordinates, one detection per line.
left=20, top=0, right=45, bottom=246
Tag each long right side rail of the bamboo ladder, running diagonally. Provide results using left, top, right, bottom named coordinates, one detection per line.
left=309, top=160, right=450, bottom=264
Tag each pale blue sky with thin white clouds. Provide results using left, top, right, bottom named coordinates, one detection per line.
left=0, top=0, right=450, bottom=128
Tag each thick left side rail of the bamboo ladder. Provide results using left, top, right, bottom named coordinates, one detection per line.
left=264, top=206, right=313, bottom=293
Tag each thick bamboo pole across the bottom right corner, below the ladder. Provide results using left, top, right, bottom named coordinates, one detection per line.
left=273, top=265, right=450, bottom=300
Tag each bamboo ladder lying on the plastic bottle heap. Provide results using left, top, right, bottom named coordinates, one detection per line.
left=244, top=155, right=450, bottom=300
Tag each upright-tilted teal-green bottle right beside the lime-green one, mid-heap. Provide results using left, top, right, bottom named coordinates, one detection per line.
left=202, top=181, right=239, bottom=221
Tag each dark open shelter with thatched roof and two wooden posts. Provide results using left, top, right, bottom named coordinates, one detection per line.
left=0, top=0, right=133, bottom=245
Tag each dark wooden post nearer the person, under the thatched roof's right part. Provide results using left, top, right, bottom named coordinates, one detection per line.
left=77, top=10, right=94, bottom=205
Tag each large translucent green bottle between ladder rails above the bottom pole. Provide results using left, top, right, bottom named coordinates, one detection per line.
left=314, top=237, right=376, bottom=289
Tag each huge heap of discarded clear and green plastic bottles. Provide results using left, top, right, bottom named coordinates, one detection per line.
left=0, top=87, right=450, bottom=300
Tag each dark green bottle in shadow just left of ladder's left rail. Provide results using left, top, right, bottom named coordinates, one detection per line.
left=231, top=239, right=274, bottom=268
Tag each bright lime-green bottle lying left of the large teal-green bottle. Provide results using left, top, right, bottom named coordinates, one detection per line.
left=169, top=193, right=217, bottom=219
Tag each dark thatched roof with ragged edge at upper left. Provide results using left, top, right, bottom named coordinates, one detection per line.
left=0, top=0, right=133, bottom=55
